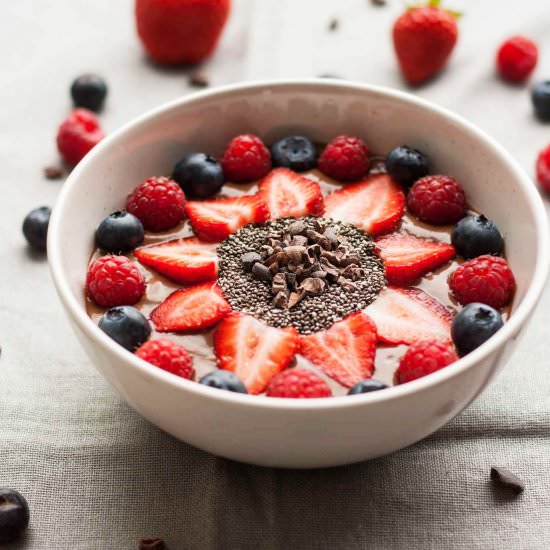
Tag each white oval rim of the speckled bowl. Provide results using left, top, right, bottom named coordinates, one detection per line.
left=48, top=78, right=550, bottom=411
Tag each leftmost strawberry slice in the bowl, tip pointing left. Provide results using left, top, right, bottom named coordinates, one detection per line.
left=134, top=237, right=218, bottom=285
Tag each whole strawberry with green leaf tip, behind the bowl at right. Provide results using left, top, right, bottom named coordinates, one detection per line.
left=393, top=0, right=458, bottom=85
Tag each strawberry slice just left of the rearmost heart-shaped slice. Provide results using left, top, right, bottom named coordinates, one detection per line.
left=185, top=195, right=269, bottom=242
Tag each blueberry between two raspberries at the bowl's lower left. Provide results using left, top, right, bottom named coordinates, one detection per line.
left=99, top=306, right=151, bottom=351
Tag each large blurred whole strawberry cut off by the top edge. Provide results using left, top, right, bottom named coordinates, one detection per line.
left=139, top=0, right=231, bottom=65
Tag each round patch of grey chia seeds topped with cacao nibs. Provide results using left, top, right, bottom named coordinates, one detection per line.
left=218, top=216, right=386, bottom=334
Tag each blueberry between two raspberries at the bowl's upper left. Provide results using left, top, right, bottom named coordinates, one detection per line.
left=95, top=210, right=144, bottom=253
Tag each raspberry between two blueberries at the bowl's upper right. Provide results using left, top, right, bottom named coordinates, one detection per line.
left=407, top=176, right=466, bottom=225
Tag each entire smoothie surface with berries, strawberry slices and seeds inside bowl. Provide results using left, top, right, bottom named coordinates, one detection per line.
left=87, top=134, right=516, bottom=399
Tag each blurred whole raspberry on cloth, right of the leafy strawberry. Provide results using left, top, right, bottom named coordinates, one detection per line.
left=496, top=36, right=538, bottom=82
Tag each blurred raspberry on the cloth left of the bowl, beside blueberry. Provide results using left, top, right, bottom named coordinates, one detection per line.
left=57, top=109, right=103, bottom=164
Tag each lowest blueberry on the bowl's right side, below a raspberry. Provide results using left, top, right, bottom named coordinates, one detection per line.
left=451, top=302, right=503, bottom=357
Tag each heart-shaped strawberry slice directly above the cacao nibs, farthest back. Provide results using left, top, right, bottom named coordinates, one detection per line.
left=258, top=168, right=325, bottom=220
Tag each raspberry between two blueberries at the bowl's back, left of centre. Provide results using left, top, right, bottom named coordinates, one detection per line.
left=221, top=134, right=271, bottom=182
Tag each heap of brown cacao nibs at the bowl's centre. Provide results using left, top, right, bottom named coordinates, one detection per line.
left=246, top=220, right=365, bottom=309
